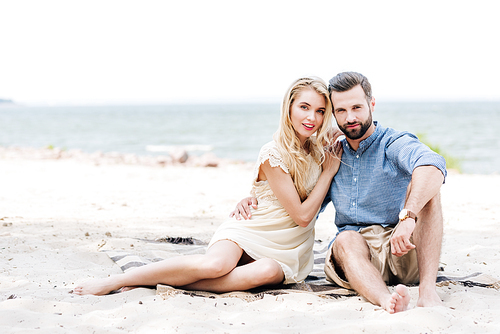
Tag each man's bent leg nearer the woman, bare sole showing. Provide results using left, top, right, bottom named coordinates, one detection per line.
left=332, top=231, right=410, bottom=313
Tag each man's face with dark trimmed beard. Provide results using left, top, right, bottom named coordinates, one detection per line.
left=332, top=85, right=375, bottom=140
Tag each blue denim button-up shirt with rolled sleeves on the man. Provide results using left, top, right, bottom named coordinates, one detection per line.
left=320, top=122, right=447, bottom=232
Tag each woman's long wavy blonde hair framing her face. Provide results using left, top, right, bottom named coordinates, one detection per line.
left=273, top=77, right=332, bottom=201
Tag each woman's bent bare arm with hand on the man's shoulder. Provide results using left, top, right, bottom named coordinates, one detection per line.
left=260, top=143, right=342, bottom=227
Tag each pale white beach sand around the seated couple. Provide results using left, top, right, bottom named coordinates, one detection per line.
left=0, top=157, right=500, bottom=333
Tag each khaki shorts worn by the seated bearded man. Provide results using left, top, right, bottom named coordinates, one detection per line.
left=325, top=225, right=419, bottom=290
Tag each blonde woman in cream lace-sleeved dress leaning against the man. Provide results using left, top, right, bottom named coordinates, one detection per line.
left=73, top=77, right=342, bottom=295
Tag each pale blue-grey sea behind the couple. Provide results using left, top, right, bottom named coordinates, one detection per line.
left=0, top=102, right=500, bottom=174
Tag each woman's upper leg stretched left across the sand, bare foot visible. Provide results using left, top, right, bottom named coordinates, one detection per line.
left=73, top=240, right=243, bottom=295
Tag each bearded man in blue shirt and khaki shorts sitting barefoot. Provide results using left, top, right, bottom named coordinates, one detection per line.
left=231, top=72, right=446, bottom=313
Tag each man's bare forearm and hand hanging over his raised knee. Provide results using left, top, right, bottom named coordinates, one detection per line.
left=391, top=166, right=444, bottom=256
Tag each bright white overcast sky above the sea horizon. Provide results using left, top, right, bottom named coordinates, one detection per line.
left=0, top=0, right=500, bottom=105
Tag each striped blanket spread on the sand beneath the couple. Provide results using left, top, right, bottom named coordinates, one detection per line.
left=101, top=237, right=500, bottom=301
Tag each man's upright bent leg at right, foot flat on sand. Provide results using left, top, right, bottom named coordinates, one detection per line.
left=413, top=194, right=443, bottom=307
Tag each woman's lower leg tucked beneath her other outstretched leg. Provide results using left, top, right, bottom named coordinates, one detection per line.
left=183, top=259, right=285, bottom=293
